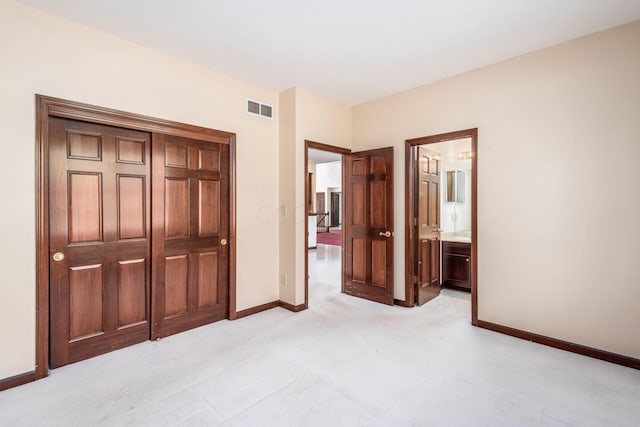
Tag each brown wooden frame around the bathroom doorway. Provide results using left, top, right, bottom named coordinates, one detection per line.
left=396, top=128, right=478, bottom=326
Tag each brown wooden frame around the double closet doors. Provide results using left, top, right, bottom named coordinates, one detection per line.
left=35, top=94, right=237, bottom=379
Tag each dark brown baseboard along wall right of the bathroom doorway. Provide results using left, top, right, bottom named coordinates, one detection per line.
left=477, top=320, right=640, bottom=369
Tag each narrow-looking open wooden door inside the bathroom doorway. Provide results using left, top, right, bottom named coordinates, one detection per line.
left=415, top=147, right=441, bottom=305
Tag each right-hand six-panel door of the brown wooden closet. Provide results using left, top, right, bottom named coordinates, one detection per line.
left=151, top=134, right=230, bottom=339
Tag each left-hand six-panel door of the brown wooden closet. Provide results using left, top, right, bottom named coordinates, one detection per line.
left=48, top=118, right=151, bottom=368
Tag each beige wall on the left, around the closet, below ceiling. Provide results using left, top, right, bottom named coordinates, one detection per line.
left=0, top=1, right=279, bottom=379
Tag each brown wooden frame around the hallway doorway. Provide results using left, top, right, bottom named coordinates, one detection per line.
left=304, top=139, right=351, bottom=309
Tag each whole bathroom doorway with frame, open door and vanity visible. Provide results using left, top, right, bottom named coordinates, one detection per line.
left=405, top=129, right=478, bottom=324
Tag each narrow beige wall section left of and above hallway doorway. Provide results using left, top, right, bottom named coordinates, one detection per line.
left=280, top=87, right=351, bottom=305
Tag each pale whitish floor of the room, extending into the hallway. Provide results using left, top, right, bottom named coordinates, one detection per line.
left=0, top=247, right=640, bottom=427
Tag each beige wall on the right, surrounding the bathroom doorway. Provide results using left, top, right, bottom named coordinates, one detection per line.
left=353, top=21, right=640, bottom=358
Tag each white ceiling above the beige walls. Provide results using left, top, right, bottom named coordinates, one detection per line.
left=16, top=0, right=640, bottom=105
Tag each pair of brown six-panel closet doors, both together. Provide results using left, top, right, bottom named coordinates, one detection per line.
left=48, top=117, right=230, bottom=368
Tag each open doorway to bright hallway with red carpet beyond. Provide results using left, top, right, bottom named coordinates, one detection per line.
left=305, top=141, right=349, bottom=307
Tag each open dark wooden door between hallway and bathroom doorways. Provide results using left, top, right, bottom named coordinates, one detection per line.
left=343, top=147, right=393, bottom=305
